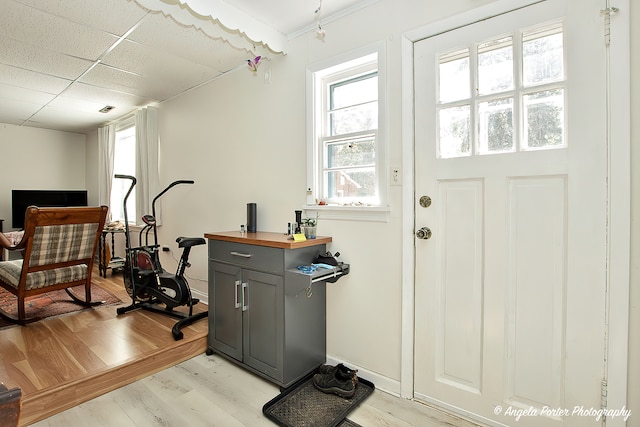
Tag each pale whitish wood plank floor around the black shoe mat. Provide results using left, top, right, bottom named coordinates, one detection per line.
left=34, top=355, right=475, bottom=427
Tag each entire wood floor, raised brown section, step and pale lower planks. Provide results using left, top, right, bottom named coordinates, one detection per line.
left=0, top=270, right=475, bottom=427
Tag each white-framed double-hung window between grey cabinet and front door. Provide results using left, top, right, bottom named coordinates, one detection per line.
left=308, top=46, right=386, bottom=212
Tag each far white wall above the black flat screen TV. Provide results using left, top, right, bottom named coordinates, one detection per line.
left=0, top=123, right=87, bottom=230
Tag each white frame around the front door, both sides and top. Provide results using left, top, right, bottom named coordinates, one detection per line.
left=400, top=0, right=631, bottom=426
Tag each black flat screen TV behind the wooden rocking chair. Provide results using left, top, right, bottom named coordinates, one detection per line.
left=11, top=190, right=87, bottom=229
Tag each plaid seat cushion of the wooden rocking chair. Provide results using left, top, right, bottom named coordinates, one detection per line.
left=0, top=259, right=88, bottom=289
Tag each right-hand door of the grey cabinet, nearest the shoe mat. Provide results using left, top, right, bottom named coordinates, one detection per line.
left=243, top=270, right=284, bottom=381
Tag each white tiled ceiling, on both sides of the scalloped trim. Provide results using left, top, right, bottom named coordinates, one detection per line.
left=0, top=0, right=375, bottom=133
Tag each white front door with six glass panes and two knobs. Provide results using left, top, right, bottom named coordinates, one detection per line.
left=414, top=0, right=607, bottom=426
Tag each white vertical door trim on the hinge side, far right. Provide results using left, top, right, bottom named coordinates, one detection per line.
left=606, top=0, right=631, bottom=427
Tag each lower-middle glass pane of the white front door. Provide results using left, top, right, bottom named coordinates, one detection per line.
left=478, top=98, right=515, bottom=154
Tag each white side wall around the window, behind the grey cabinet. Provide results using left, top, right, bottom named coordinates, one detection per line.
left=154, top=0, right=496, bottom=392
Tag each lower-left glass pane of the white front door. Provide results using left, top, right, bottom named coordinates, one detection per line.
left=438, top=105, right=471, bottom=158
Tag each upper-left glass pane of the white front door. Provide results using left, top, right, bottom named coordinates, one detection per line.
left=438, top=49, right=471, bottom=102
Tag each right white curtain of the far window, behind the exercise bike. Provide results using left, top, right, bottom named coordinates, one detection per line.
left=136, top=107, right=162, bottom=225
